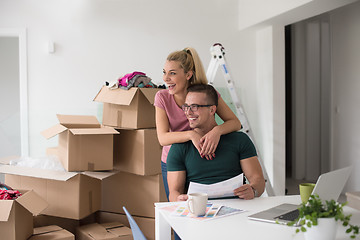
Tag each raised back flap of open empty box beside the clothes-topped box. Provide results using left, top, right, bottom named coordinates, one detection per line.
left=56, top=114, right=100, bottom=128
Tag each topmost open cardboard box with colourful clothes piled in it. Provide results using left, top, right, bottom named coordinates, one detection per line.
left=94, top=86, right=160, bottom=129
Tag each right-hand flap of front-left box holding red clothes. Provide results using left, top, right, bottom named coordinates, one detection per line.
left=16, top=190, right=49, bottom=216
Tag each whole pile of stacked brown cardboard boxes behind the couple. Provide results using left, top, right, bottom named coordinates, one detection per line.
left=0, top=87, right=166, bottom=239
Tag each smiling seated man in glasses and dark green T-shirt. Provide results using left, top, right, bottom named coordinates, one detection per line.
left=167, top=84, right=265, bottom=201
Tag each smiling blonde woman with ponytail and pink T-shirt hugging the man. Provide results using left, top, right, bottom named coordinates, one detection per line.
left=154, top=48, right=241, bottom=197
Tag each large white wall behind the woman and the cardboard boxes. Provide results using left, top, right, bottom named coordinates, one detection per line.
left=0, top=0, right=241, bottom=157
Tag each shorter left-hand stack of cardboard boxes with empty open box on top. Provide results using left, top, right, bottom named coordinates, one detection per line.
left=0, top=115, right=119, bottom=239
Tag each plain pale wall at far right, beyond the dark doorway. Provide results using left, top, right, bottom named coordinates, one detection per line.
left=330, top=2, right=360, bottom=191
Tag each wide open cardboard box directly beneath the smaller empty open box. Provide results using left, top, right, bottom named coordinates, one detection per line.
left=0, top=165, right=115, bottom=219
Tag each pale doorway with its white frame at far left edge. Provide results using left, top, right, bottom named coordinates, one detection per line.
left=0, top=29, right=29, bottom=181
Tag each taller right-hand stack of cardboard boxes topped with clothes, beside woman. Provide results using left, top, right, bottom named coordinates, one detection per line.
left=94, top=87, right=167, bottom=239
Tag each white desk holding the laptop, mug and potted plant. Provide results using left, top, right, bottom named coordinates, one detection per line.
left=155, top=195, right=360, bottom=240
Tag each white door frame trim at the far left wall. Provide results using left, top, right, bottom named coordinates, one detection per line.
left=0, top=28, right=29, bottom=157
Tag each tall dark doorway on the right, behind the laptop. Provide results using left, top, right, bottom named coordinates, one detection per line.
left=285, top=14, right=331, bottom=194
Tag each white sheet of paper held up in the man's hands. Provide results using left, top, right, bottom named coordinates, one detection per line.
left=187, top=173, right=244, bottom=198
